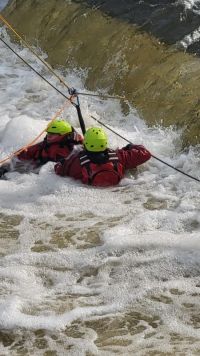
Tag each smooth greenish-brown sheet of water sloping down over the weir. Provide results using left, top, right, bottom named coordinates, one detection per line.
left=4, top=0, right=200, bottom=144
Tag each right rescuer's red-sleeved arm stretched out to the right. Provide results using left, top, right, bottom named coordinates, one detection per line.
left=117, top=144, right=151, bottom=169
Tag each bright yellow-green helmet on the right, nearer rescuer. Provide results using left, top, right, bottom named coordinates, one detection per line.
left=83, top=127, right=108, bottom=152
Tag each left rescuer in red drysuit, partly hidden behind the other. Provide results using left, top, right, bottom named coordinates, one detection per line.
left=0, top=119, right=83, bottom=177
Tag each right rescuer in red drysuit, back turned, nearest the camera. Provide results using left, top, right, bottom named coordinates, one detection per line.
left=55, top=127, right=151, bottom=187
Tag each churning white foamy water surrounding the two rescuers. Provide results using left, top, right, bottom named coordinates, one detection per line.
left=0, top=30, right=200, bottom=355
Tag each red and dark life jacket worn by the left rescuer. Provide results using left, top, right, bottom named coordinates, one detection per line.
left=37, top=131, right=82, bottom=164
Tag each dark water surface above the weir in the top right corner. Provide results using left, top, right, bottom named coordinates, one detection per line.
left=80, top=0, right=200, bottom=54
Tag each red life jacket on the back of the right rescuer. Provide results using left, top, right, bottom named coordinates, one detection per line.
left=79, top=150, right=124, bottom=187
